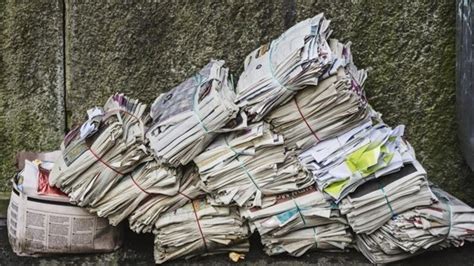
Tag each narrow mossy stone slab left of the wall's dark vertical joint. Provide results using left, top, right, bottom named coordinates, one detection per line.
left=0, top=0, right=65, bottom=191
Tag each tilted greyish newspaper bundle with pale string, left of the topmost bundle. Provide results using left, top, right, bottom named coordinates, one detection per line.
left=146, top=60, right=246, bottom=166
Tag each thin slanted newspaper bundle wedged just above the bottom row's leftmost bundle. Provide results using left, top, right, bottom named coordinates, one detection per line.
left=129, top=166, right=206, bottom=233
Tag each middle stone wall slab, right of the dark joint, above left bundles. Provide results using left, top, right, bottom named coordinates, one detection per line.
left=67, top=0, right=286, bottom=123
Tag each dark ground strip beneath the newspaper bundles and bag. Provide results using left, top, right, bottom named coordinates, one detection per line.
left=0, top=219, right=474, bottom=266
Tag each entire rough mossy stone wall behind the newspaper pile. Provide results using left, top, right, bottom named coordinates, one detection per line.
left=0, top=0, right=474, bottom=203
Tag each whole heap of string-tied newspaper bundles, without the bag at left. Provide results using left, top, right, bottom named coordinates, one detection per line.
left=12, top=14, right=474, bottom=263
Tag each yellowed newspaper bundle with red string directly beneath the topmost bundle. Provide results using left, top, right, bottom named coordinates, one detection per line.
left=264, top=39, right=370, bottom=150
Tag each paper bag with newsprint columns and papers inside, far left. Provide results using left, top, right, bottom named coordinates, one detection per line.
left=7, top=155, right=122, bottom=256
